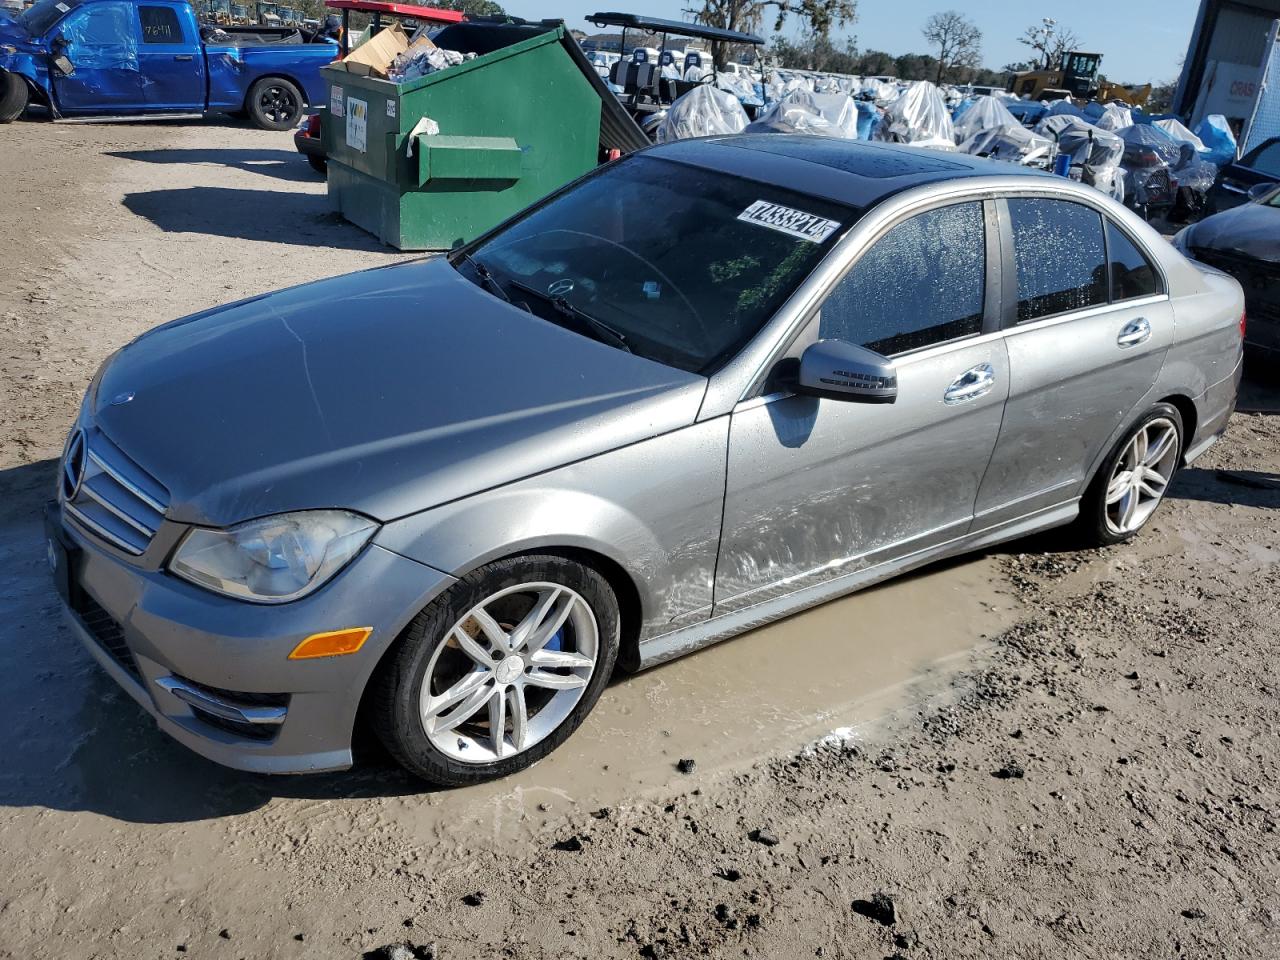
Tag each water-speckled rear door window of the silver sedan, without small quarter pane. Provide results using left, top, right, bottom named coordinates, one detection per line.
left=1009, top=200, right=1107, bottom=324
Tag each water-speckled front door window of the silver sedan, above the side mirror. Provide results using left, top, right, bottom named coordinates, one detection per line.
left=818, top=204, right=987, bottom=356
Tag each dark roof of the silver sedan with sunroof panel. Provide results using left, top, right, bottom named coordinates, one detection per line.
left=645, top=133, right=1051, bottom=209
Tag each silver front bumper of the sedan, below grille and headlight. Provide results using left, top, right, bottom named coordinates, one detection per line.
left=45, top=502, right=454, bottom=773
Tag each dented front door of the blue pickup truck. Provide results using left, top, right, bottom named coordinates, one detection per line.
left=50, top=0, right=146, bottom=114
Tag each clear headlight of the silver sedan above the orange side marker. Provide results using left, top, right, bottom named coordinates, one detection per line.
left=169, top=509, right=378, bottom=603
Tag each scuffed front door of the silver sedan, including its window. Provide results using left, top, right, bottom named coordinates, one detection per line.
left=716, top=201, right=1009, bottom=614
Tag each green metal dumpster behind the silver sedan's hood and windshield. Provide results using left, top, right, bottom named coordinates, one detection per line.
left=321, top=22, right=648, bottom=250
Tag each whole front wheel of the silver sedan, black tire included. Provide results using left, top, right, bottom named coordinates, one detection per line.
left=370, top=554, right=621, bottom=786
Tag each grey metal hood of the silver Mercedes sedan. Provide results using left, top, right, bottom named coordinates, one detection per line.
left=91, top=257, right=707, bottom=526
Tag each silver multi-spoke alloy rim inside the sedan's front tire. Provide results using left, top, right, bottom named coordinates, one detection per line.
left=419, top=582, right=599, bottom=763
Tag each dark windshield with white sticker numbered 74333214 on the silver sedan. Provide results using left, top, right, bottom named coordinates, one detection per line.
left=456, top=156, right=859, bottom=374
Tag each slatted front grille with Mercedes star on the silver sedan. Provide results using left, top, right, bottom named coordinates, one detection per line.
left=60, top=430, right=169, bottom=557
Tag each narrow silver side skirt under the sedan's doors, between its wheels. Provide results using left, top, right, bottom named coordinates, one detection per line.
left=639, top=499, right=1080, bottom=669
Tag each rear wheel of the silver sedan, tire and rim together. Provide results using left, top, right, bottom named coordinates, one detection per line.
left=1076, top=403, right=1184, bottom=547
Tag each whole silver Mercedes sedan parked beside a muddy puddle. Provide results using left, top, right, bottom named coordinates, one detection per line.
left=47, top=134, right=1244, bottom=783
